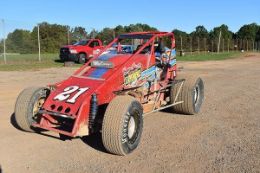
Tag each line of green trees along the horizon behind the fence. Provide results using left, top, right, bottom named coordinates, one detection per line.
left=0, top=22, right=260, bottom=53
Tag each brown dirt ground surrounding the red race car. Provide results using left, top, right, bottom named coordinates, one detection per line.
left=0, top=54, right=260, bottom=173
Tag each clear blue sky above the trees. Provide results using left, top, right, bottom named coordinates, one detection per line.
left=0, top=0, right=260, bottom=35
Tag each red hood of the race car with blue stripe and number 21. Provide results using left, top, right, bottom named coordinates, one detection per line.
left=43, top=54, right=131, bottom=117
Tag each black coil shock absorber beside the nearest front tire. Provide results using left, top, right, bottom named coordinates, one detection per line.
left=89, top=93, right=98, bottom=132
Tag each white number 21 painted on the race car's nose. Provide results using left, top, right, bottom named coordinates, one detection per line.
left=54, top=86, right=89, bottom=103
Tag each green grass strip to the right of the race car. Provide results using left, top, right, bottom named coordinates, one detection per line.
left=177, top=52, right=242, bottom=61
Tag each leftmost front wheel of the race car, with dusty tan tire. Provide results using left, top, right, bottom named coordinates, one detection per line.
left=14, top=87, right=50, bottom=132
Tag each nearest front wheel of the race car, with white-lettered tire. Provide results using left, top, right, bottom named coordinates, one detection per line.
left=102, top=96, right=143, bottom=155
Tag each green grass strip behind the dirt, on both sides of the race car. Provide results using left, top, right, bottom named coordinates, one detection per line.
left=0, top=52, right=244, bottom=71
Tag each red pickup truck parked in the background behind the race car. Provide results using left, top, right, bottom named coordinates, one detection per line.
left=60, top=39, right=104, bottom=64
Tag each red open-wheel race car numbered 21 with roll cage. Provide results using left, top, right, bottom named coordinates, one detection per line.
left=15, top=32, right=204, bottom=155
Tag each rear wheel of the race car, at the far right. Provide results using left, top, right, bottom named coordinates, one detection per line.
left=170, top=76, right=204, bottom=115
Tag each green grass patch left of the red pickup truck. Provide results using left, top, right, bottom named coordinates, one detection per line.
left=0, top=54, right=80, bottom=71
